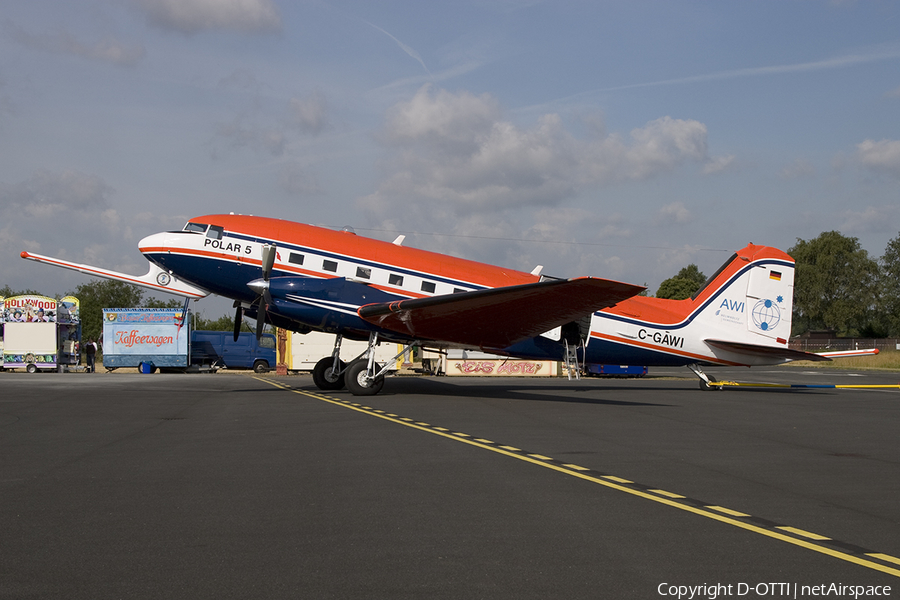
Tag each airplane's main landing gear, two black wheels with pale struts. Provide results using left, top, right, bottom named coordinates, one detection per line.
left=313, top=332, right=408, bottom=396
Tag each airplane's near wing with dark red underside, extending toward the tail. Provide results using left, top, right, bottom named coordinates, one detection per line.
left=358, top=277, right=645, bottom=349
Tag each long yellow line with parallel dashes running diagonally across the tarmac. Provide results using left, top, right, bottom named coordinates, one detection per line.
left=254, top=377, right=900, bottom=577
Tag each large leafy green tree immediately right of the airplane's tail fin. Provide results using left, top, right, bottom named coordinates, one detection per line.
left=788, top=231, right=878, bottom=335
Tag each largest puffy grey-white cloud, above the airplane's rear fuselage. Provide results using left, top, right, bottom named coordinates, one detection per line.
left=360, top=85, right=708, bottom=220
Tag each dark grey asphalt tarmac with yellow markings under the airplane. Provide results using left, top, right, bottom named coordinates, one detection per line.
left=0, top=368, right=900, bottom=600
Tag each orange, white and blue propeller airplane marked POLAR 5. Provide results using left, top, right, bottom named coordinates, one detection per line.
left=21, top=214, right=844, bottom=395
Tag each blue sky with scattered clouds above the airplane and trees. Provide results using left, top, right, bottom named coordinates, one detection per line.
left=0, top=0, right=900, bottom=318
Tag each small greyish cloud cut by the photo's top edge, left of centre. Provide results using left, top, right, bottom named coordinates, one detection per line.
left=137, top=0, right=281, bottom=34
